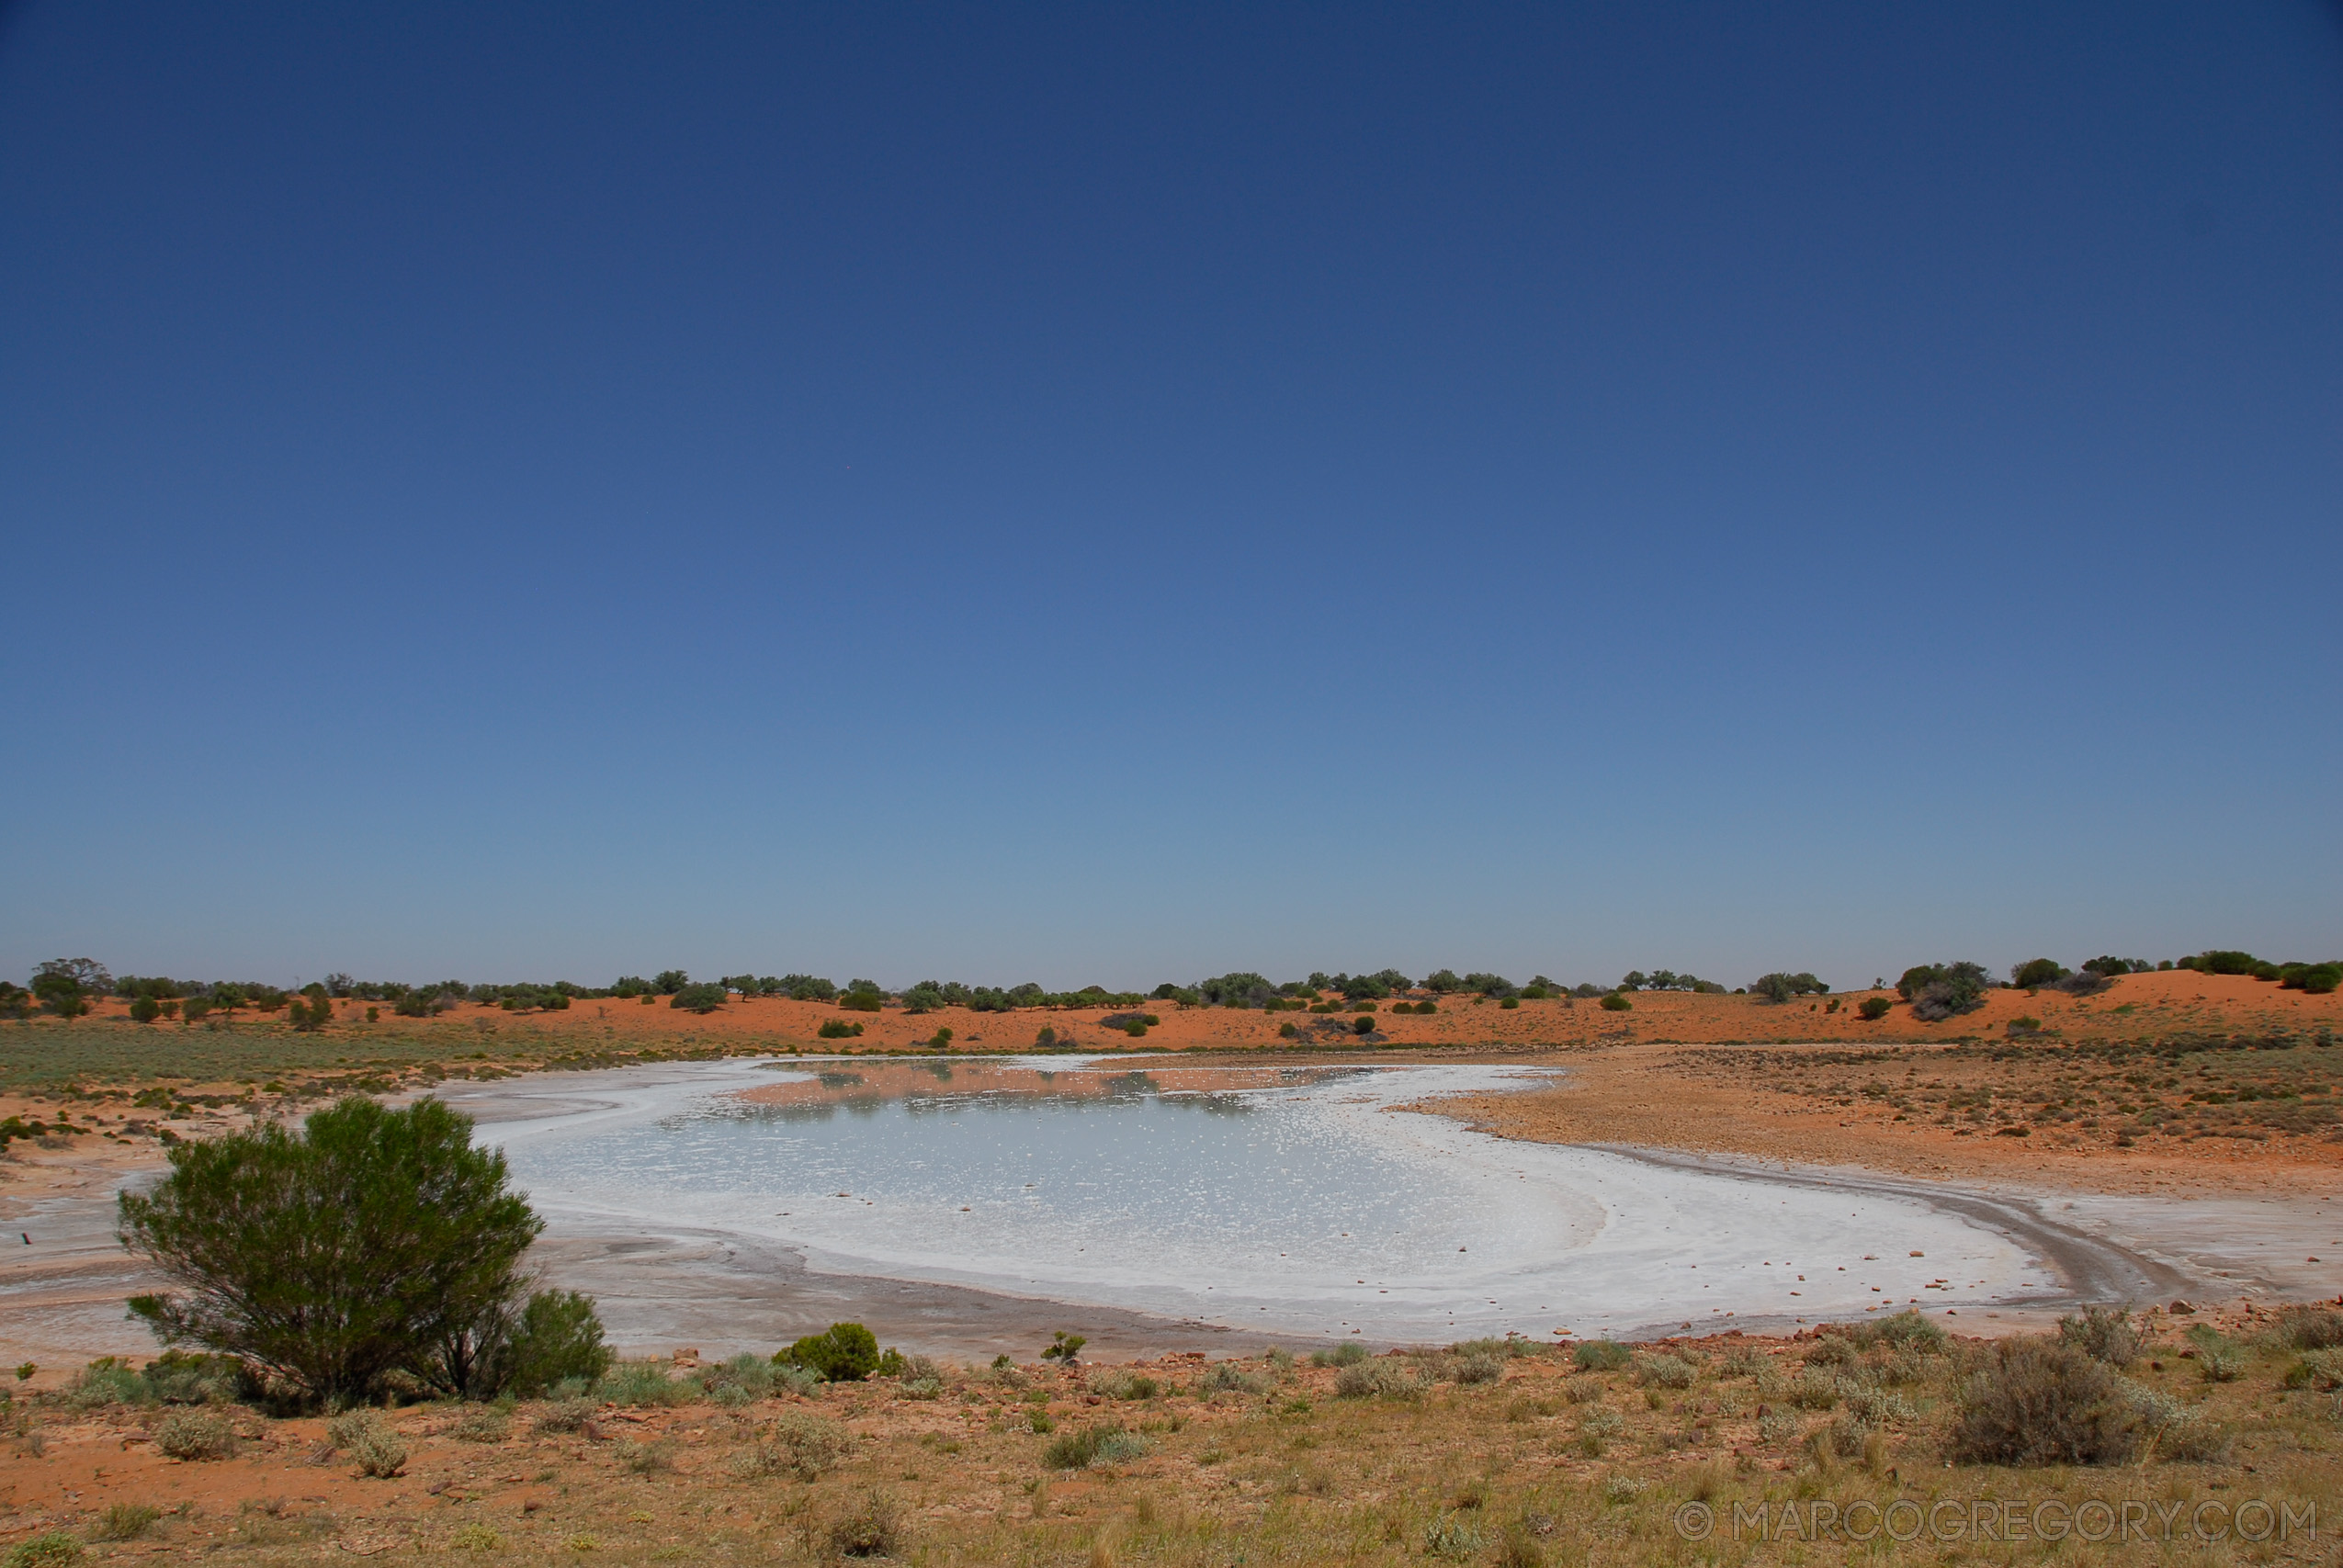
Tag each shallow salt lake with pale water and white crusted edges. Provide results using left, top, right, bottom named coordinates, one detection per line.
left=481, top=1059, right=2050, bottom=1340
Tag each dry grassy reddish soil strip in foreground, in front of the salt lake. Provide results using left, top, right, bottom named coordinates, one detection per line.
left=0, top=1305, right=2338, bottom=1568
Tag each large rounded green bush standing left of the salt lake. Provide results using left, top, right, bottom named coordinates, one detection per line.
left=119, top=1097, right=544, bottom=1402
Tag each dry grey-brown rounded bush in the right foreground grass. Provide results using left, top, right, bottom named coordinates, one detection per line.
left=1950, top=1338, right=2142, bottom=1465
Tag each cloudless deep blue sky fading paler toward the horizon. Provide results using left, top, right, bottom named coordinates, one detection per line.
left=0, top=0, right=2343, bottom=987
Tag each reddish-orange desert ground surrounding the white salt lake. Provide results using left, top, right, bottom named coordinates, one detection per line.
left=0, top=973, right=2343, bottom=1563
